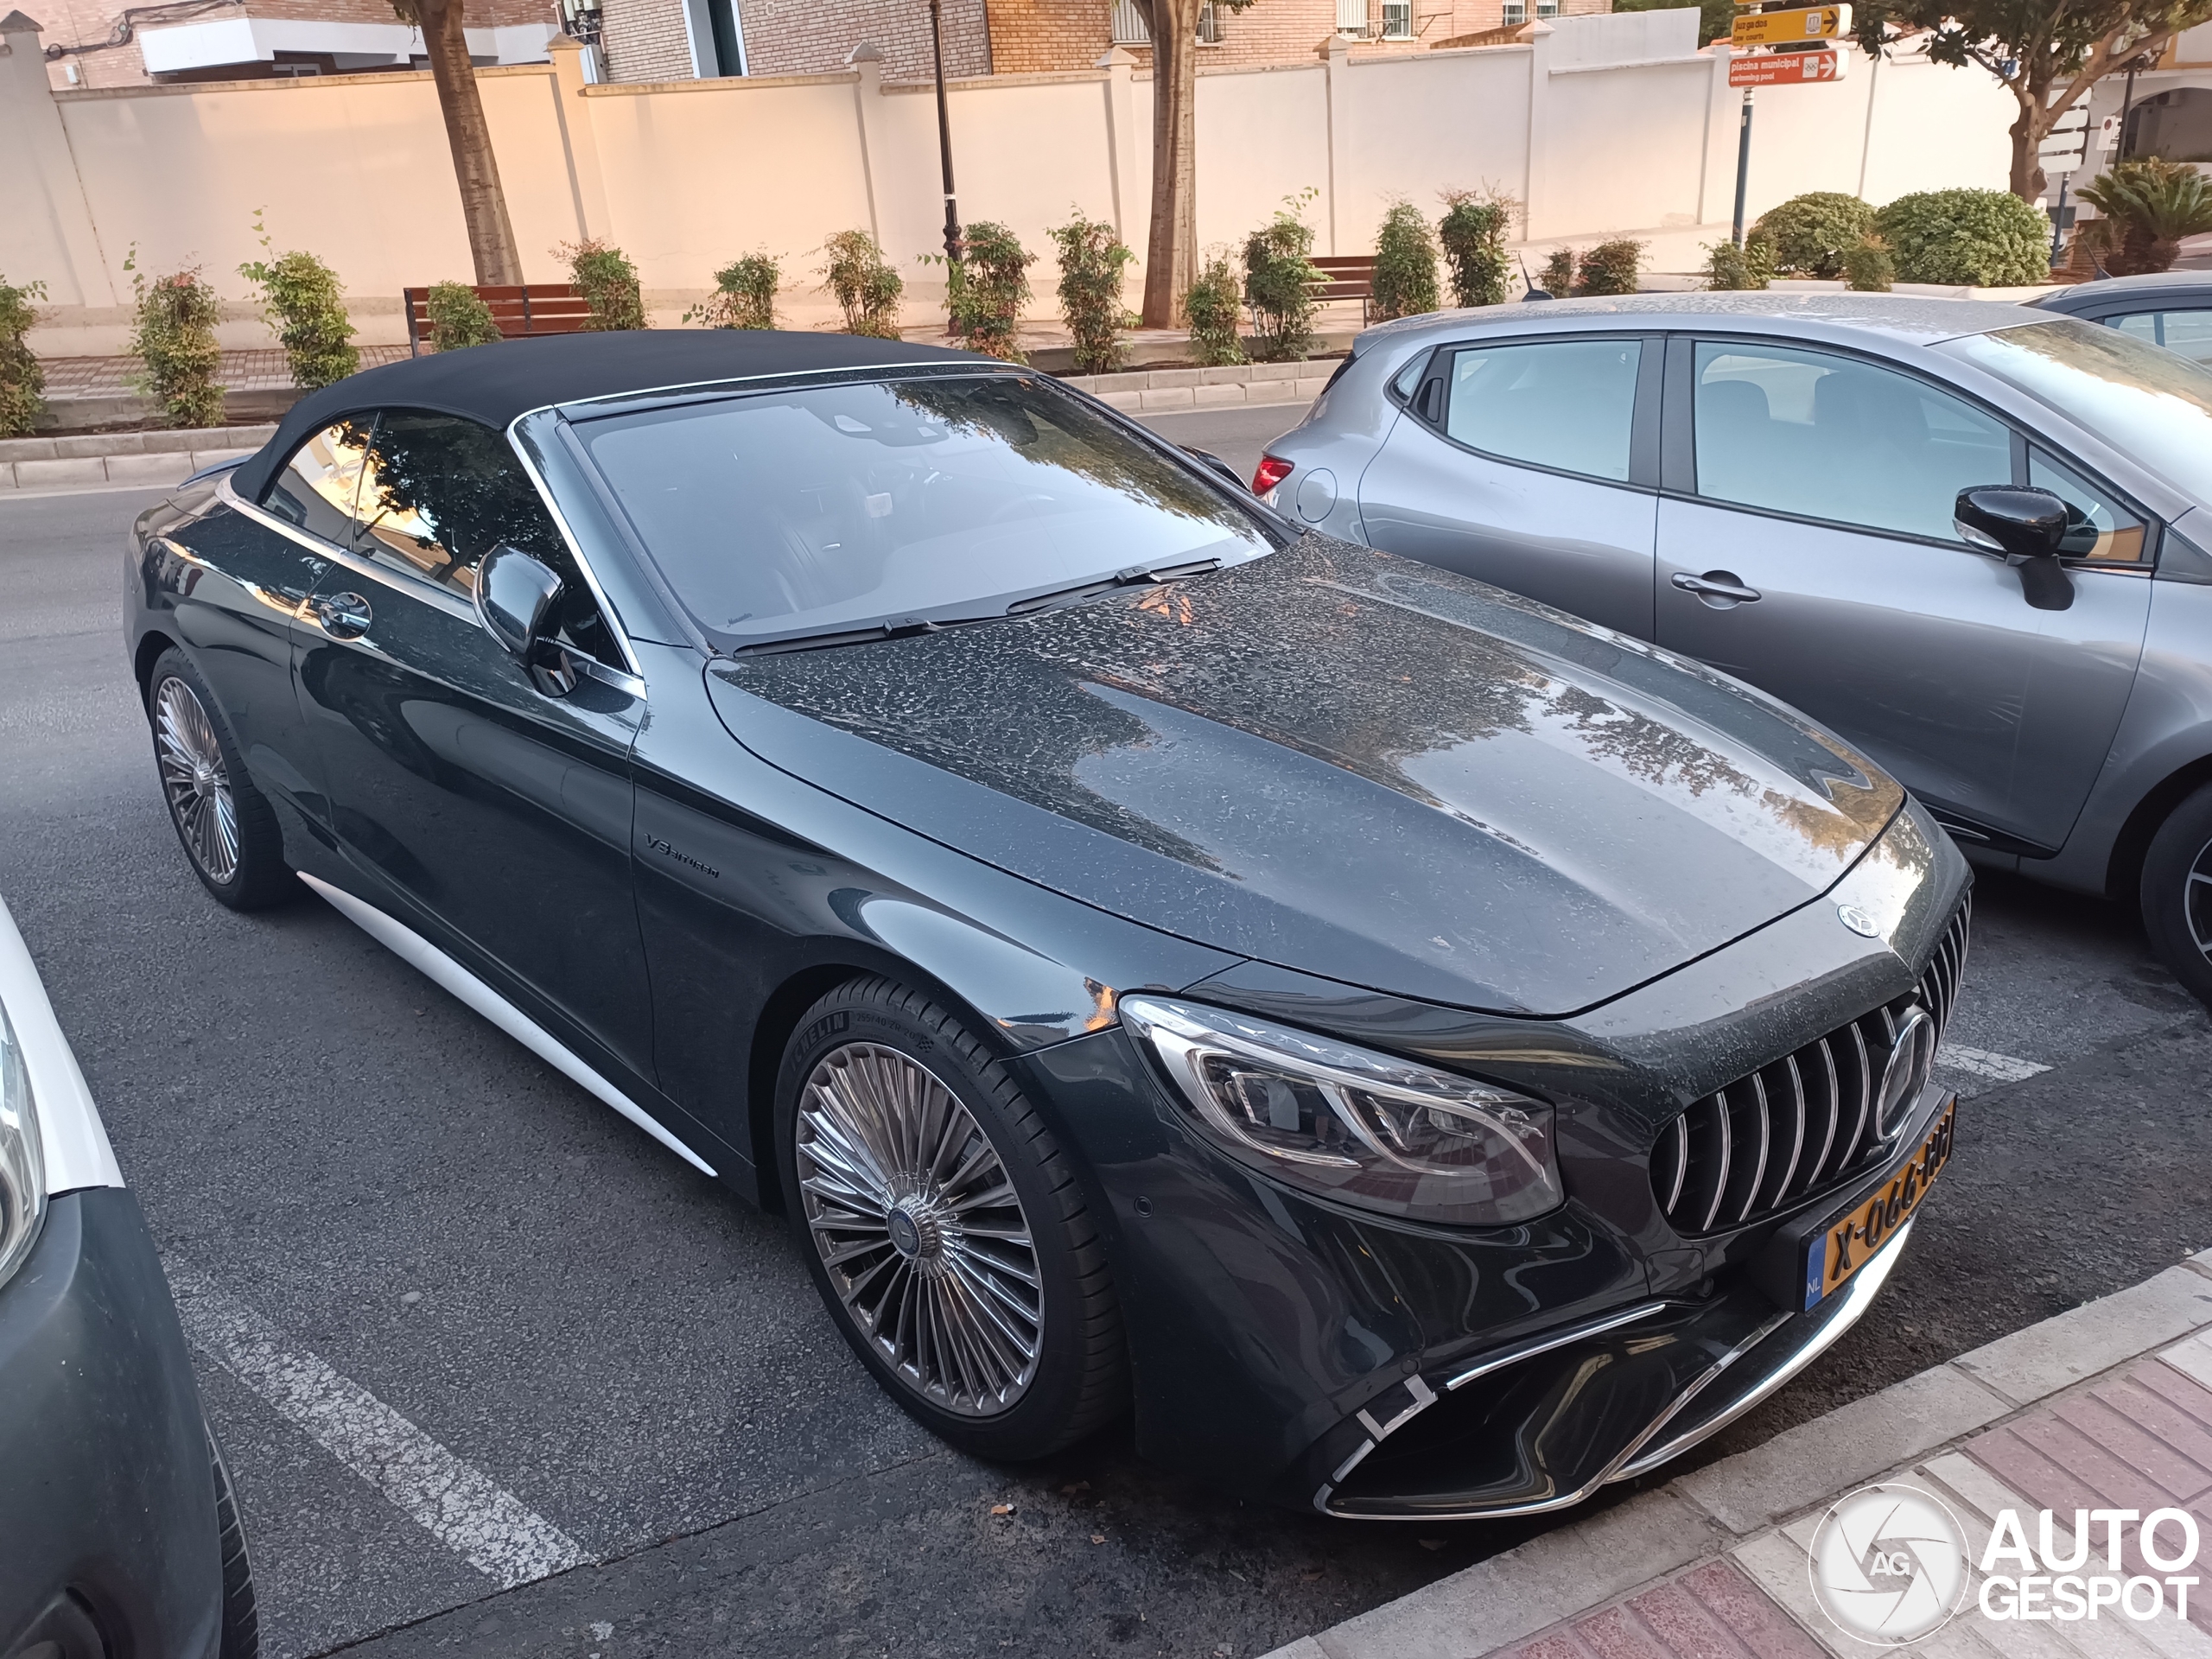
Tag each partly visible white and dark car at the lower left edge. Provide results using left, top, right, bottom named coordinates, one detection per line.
left=0, top=902, right=257, bottom=1659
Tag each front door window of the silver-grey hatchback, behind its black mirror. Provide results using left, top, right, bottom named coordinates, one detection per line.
left=1692, top=340, right=2013, bottom=542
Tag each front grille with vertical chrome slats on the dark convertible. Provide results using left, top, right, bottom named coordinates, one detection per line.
left=1652, top=905, right=1971, bottom=1236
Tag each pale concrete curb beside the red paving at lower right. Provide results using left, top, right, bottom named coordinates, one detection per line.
left=1268, top=1249, right=2212, bottom=1659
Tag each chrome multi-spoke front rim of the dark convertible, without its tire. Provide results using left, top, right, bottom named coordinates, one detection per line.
left=797, top=1042, right=1044, bottom=1418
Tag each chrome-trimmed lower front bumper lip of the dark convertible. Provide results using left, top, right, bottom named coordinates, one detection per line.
left=1314, top=1221, right=1913, bottom=1522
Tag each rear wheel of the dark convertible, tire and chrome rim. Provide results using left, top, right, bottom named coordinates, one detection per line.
left=146, top=646, right=299, bottom=909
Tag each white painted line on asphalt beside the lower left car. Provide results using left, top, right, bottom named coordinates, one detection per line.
left=163, top=1263, right=591, bottom=1588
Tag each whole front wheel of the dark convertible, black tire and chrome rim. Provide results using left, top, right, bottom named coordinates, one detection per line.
left=777, top=978, right=1128, bottom=1462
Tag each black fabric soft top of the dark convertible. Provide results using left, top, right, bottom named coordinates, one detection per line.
left=232, top=327, right=991, bottom=500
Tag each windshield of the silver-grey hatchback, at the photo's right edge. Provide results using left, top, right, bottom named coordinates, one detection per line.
left=1951, top=319, right=2212, bottom=500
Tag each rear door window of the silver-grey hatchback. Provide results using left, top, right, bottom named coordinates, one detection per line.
left=1445, top=340, right=1643, bottom=482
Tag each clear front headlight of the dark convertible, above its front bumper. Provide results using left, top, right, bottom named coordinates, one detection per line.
left=1122, top=998, right=1564, bottom=1228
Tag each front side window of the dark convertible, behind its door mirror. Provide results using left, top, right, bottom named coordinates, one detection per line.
left=356, top=410, right=566, bottom=595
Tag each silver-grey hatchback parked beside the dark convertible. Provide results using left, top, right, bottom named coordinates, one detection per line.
left=1252, top=292, right=2212, bottom=1002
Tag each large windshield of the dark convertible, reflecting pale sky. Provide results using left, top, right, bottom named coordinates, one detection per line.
left=580, top=374, right=1272, bottom=648
